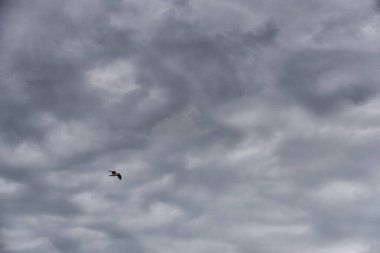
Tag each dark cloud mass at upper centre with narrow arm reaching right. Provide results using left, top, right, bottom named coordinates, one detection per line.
left=131, top=18, right=277, bottom=118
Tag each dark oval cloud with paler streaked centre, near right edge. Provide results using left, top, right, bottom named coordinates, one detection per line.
left=279, top=52, right=377, bottom=115
